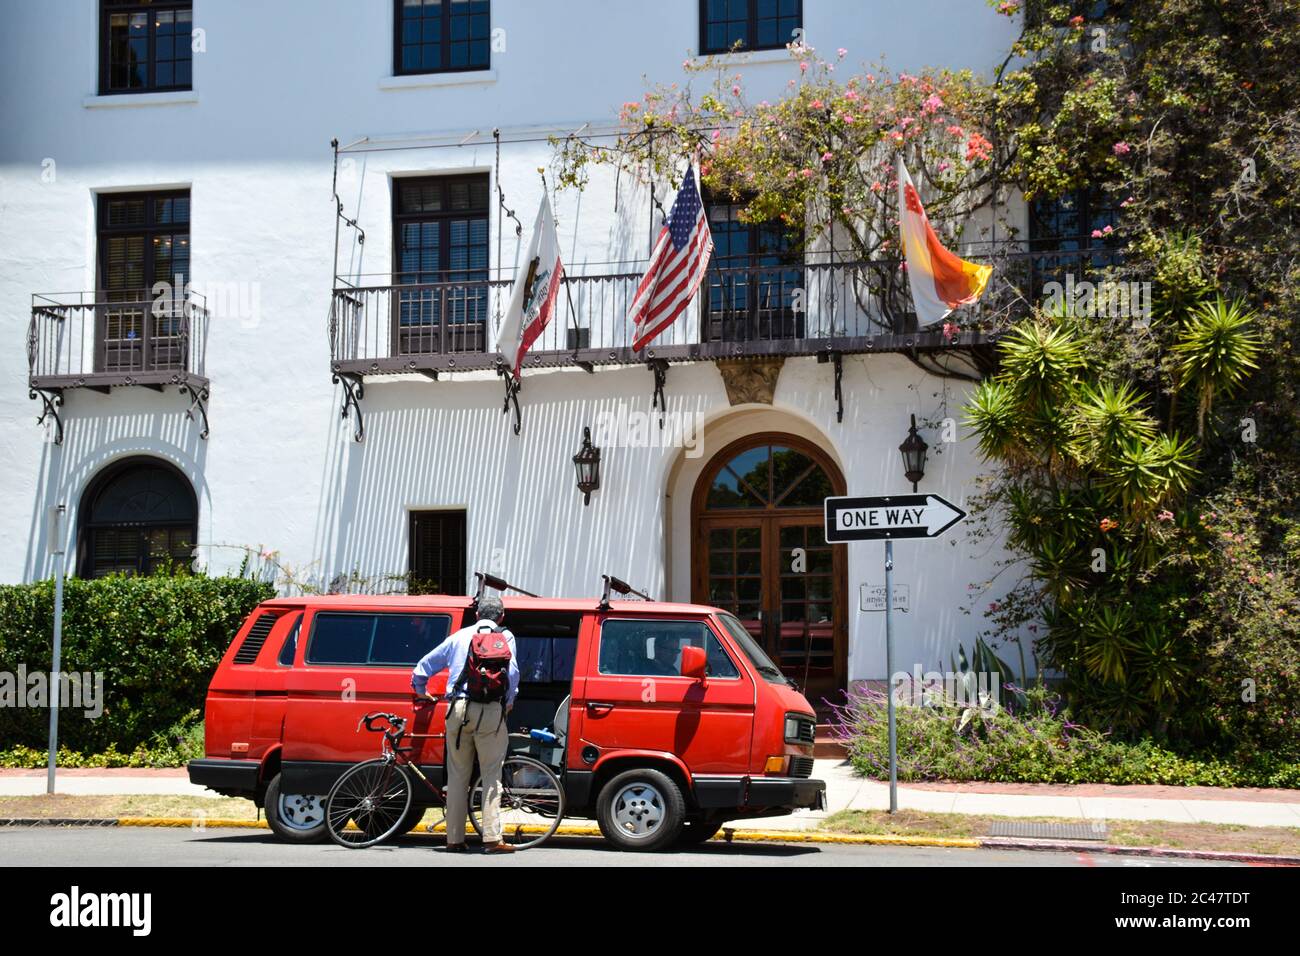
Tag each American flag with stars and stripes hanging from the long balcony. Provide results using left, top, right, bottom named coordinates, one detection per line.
left=628, top=166, right=714, bottom=351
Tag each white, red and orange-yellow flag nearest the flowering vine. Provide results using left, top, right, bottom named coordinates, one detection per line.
left=898, top=156, right=993, bottom=325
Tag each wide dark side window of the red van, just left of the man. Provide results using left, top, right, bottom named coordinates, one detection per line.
left=307, top=611, right=451, bottom=667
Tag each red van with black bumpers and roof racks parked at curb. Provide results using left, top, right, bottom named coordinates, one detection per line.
left=189, top=582, right=826, bottom=849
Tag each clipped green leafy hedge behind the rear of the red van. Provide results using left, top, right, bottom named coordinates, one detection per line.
left=0, top=574, right=274, bottom=753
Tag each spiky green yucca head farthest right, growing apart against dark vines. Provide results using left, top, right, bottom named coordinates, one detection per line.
left=1174, top=295, right=1261, bottom=436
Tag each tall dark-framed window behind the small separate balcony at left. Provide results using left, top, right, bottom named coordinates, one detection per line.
left=95, top=190, right=190, bottom=372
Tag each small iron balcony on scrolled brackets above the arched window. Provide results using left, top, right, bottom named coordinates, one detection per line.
left=27, top=291, right=209, bottom=444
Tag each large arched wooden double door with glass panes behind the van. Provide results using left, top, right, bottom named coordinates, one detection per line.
left=690, top=432, right=848, bottom=706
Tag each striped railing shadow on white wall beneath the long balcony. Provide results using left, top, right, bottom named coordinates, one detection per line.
left=311, top=369, right=703, bottom=596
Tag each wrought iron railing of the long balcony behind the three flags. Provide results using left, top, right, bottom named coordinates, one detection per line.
left=329, top=245, right=1113, bottom=377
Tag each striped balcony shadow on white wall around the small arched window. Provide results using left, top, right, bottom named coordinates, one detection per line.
left=23, top=388, right=212, bottom=581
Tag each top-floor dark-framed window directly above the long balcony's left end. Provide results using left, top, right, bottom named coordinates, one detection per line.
left=393, top=0, right=491, bottom=75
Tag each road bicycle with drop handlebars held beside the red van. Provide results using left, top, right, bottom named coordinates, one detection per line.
left=325, top=711, right=564, bottom=849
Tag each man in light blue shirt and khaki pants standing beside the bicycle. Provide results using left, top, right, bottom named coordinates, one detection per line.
left=411, top=597, right=519, bottom=853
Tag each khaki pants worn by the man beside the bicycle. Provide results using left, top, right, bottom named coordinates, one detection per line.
left=447, top=697, right=510, bottom=844
